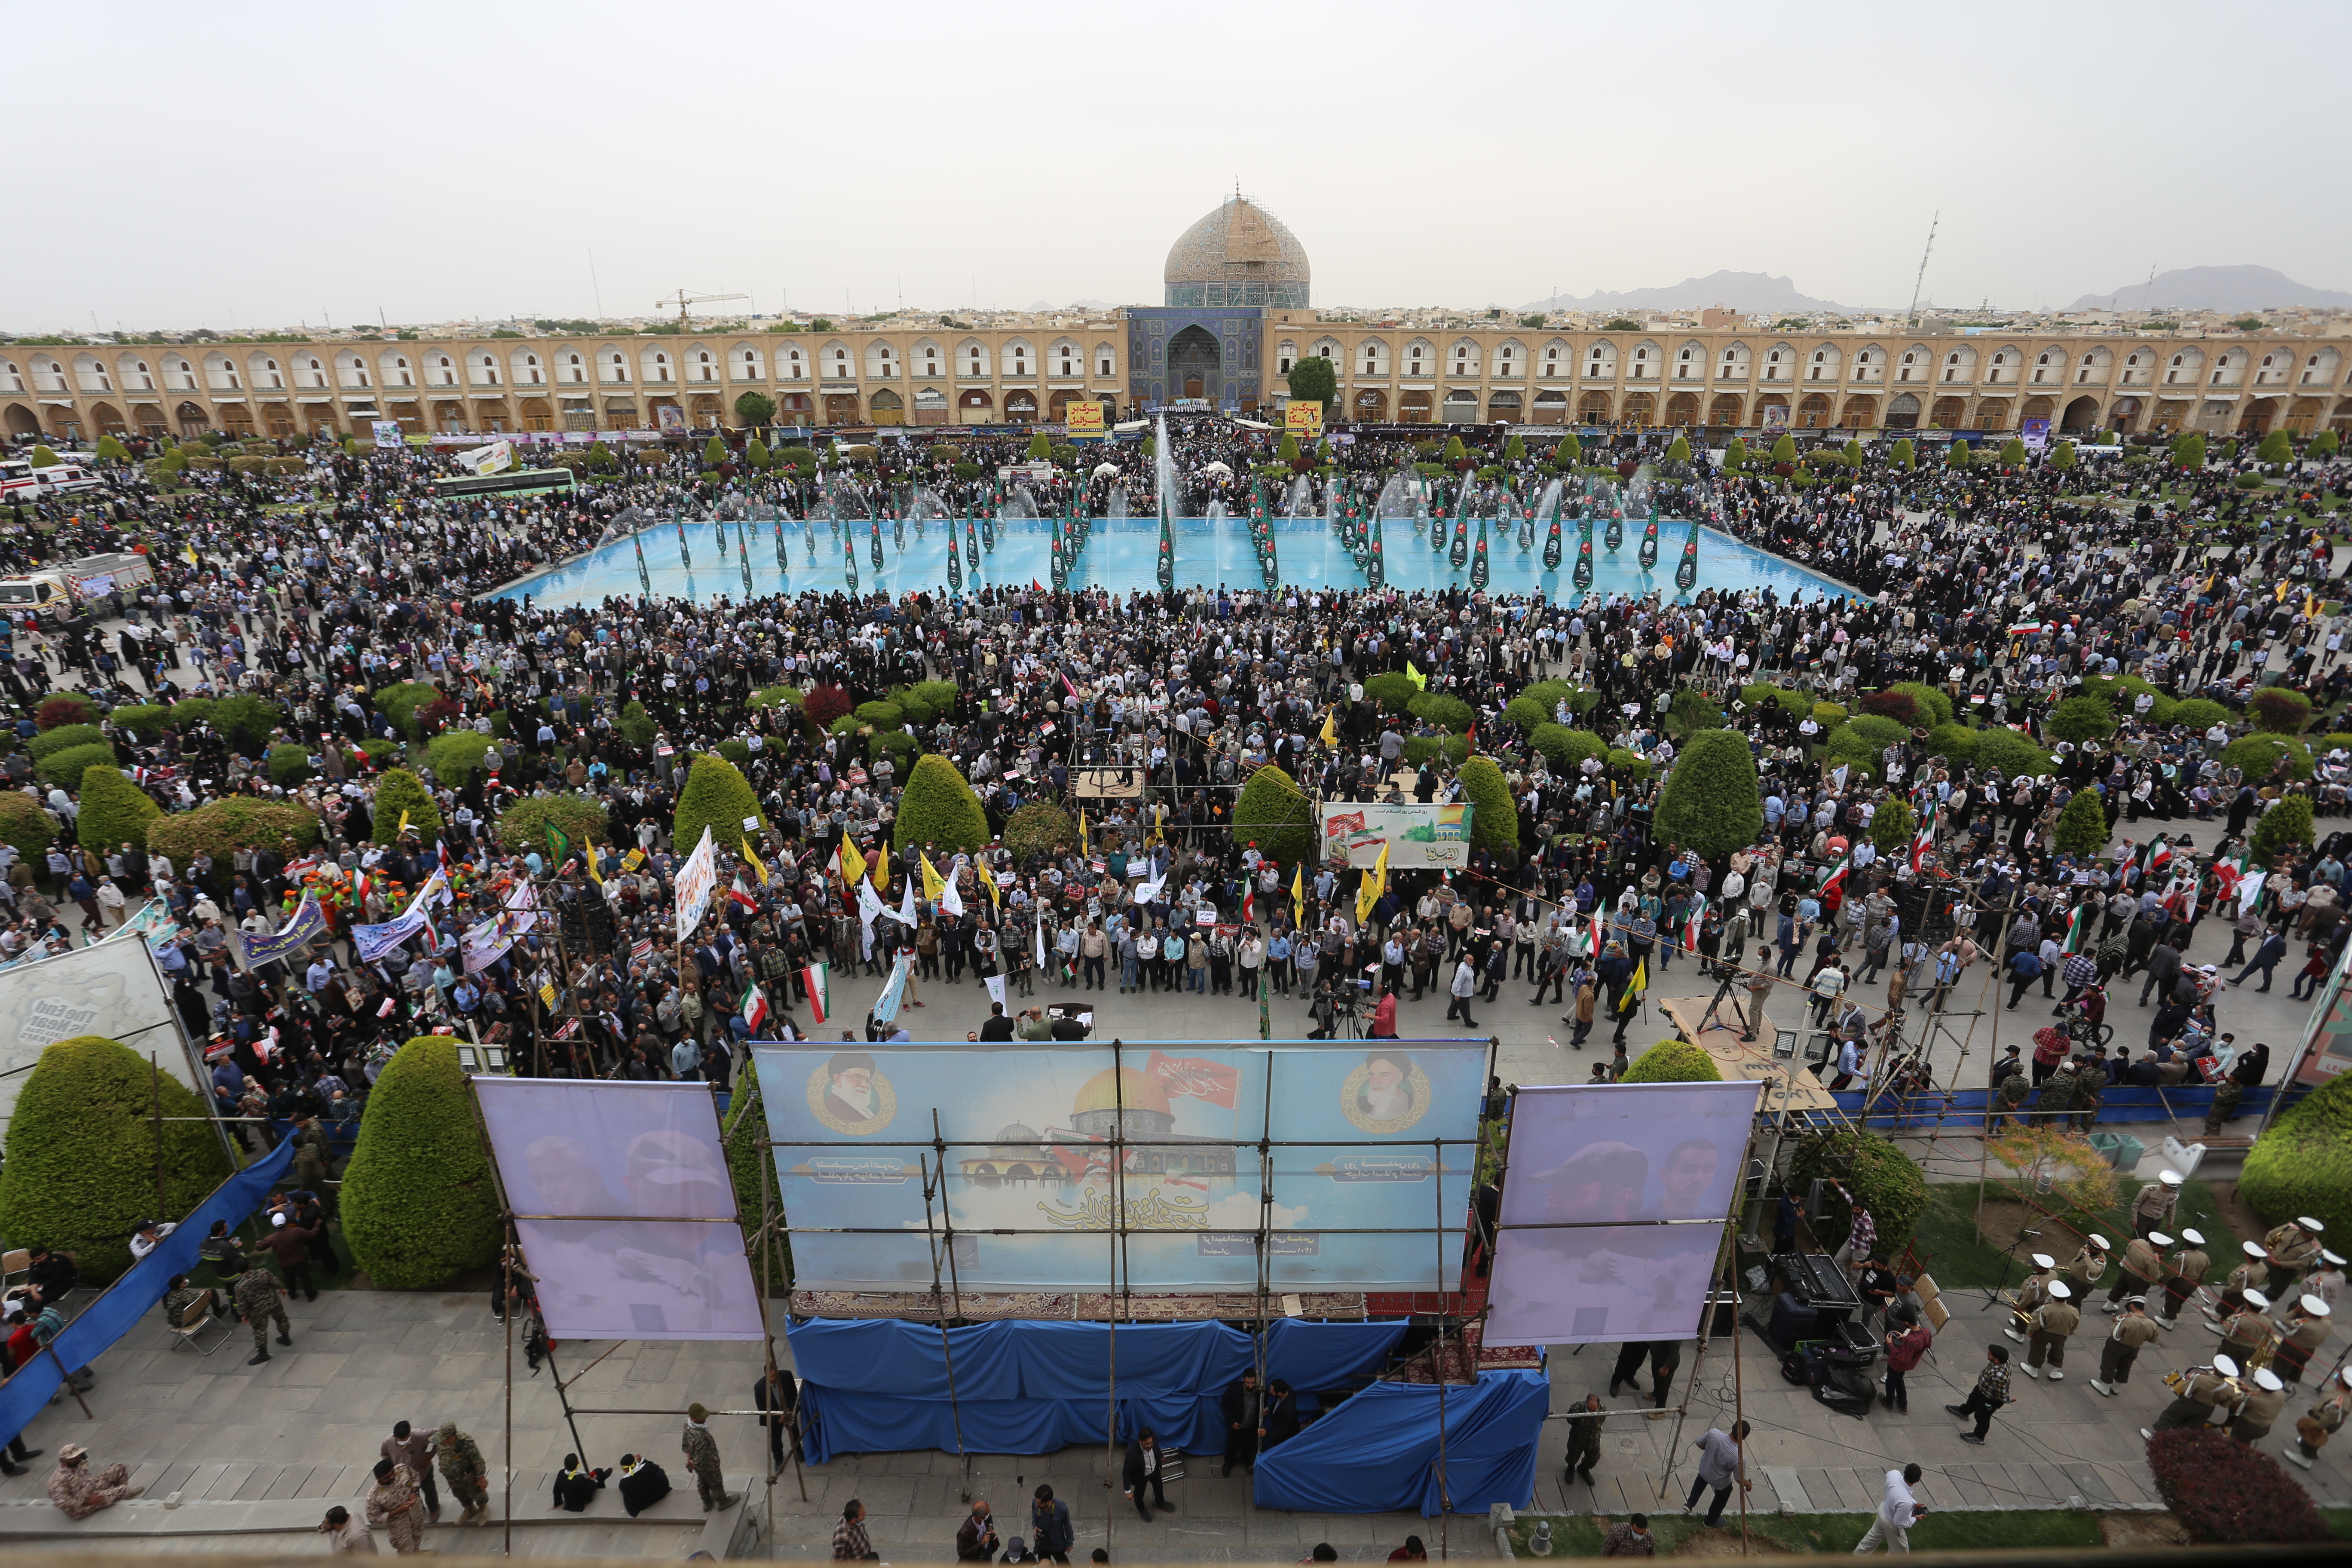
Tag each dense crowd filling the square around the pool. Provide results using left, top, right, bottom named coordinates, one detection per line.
left=0, top=421, right=2352, bottom=1121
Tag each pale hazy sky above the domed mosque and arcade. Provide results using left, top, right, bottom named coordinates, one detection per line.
left=0, top=0, right=2352, bottom=331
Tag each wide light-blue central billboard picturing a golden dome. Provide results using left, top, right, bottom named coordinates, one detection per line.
left=753, top=1039, right=1486, bottom=1291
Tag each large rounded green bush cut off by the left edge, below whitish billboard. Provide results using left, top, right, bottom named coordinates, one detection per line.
left=0, top=1034, right=228, bottom=1283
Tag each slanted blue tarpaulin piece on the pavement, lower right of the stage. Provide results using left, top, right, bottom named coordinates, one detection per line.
left=1256, top=1371, right=1553, bottom=1516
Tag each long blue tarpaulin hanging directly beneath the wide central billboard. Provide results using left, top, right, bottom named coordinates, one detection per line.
left=786, top=1319, right=1404, bottom=1464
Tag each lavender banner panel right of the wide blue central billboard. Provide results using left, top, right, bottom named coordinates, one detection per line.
left=1486, top=1081, right=1759, bottom=1344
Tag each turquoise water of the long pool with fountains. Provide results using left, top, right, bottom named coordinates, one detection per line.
left=499, top=517, right=1851, bottom=606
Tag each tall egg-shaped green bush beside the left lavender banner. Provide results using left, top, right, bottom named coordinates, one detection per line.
left=343, top=1034, right=499, bottom=1291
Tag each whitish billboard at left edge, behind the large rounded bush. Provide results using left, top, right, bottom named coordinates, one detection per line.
left=0, top=933, right=211, bottom=1121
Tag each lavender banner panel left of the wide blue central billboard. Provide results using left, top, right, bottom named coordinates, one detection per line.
left=473, top=1074, right=762, bottom=1340
